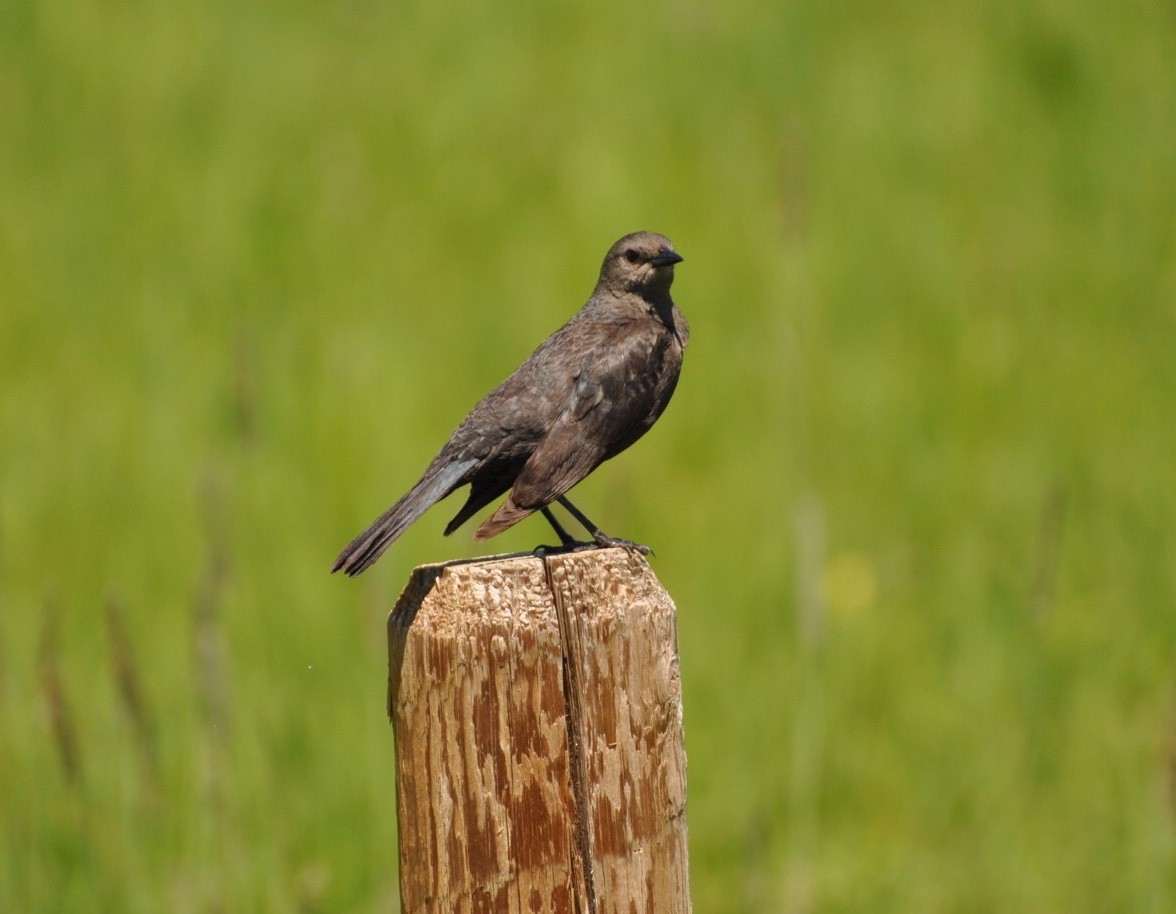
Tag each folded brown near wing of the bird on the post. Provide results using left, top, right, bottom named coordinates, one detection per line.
left=510, top=319, right=666, bottom=509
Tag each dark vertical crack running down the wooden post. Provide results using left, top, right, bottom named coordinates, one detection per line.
left=542, top=555, right=596, bottom=914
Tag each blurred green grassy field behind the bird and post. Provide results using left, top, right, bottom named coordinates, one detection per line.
left=0, top=0, right=1176, bottom=914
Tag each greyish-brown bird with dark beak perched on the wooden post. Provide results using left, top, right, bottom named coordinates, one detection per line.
left=332, top=232, right=690, bottom=576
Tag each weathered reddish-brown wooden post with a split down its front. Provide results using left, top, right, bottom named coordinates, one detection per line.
left=388, top=548, right=690, bottom=914
